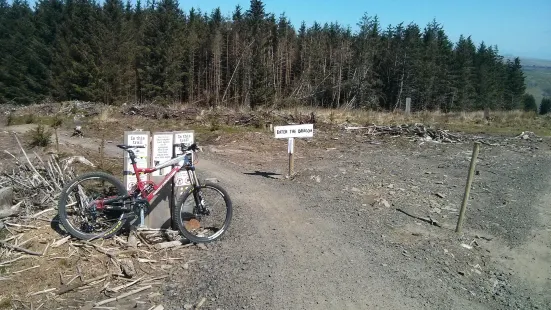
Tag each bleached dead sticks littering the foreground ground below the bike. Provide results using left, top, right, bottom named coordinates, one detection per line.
left=0, top=222, right=198, bottom=309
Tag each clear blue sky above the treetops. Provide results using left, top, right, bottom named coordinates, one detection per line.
left=179, top=0, right=551, bottom=60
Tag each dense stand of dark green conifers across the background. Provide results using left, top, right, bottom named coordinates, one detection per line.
left=0, top=0, right=525, bottom=111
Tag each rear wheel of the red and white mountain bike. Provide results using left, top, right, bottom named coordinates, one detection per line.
left=58, top=172, right=127, bottom=240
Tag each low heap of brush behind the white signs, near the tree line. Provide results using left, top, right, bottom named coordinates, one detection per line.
left=121, top=104, right=201, bottom=121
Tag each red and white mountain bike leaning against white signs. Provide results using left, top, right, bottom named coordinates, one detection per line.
left=58, top=143, right=232, bottom=243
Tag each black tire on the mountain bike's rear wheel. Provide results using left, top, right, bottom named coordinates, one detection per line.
left=57, top=172, right=127, bottom=240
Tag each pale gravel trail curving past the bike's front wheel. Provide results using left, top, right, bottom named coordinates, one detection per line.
left=162, top=159, right=490, bottom=309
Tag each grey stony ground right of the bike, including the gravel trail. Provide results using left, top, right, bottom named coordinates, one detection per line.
left=2, top=114, right=551, bottom=309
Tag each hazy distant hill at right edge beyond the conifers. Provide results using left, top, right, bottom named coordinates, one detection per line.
left=505, top=56, right=551, bottom=104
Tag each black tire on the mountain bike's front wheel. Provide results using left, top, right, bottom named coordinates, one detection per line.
left=172, top=182, right=233, bottom=243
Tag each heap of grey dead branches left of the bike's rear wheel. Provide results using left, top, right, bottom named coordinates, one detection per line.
left=0, top=133, right=94, bottom=218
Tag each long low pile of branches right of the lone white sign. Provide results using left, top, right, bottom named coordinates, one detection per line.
left=345, top=123, right=461, bottom=143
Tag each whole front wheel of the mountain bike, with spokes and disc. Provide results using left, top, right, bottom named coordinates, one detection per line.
left=172, top=183, right=233, bottom=243
